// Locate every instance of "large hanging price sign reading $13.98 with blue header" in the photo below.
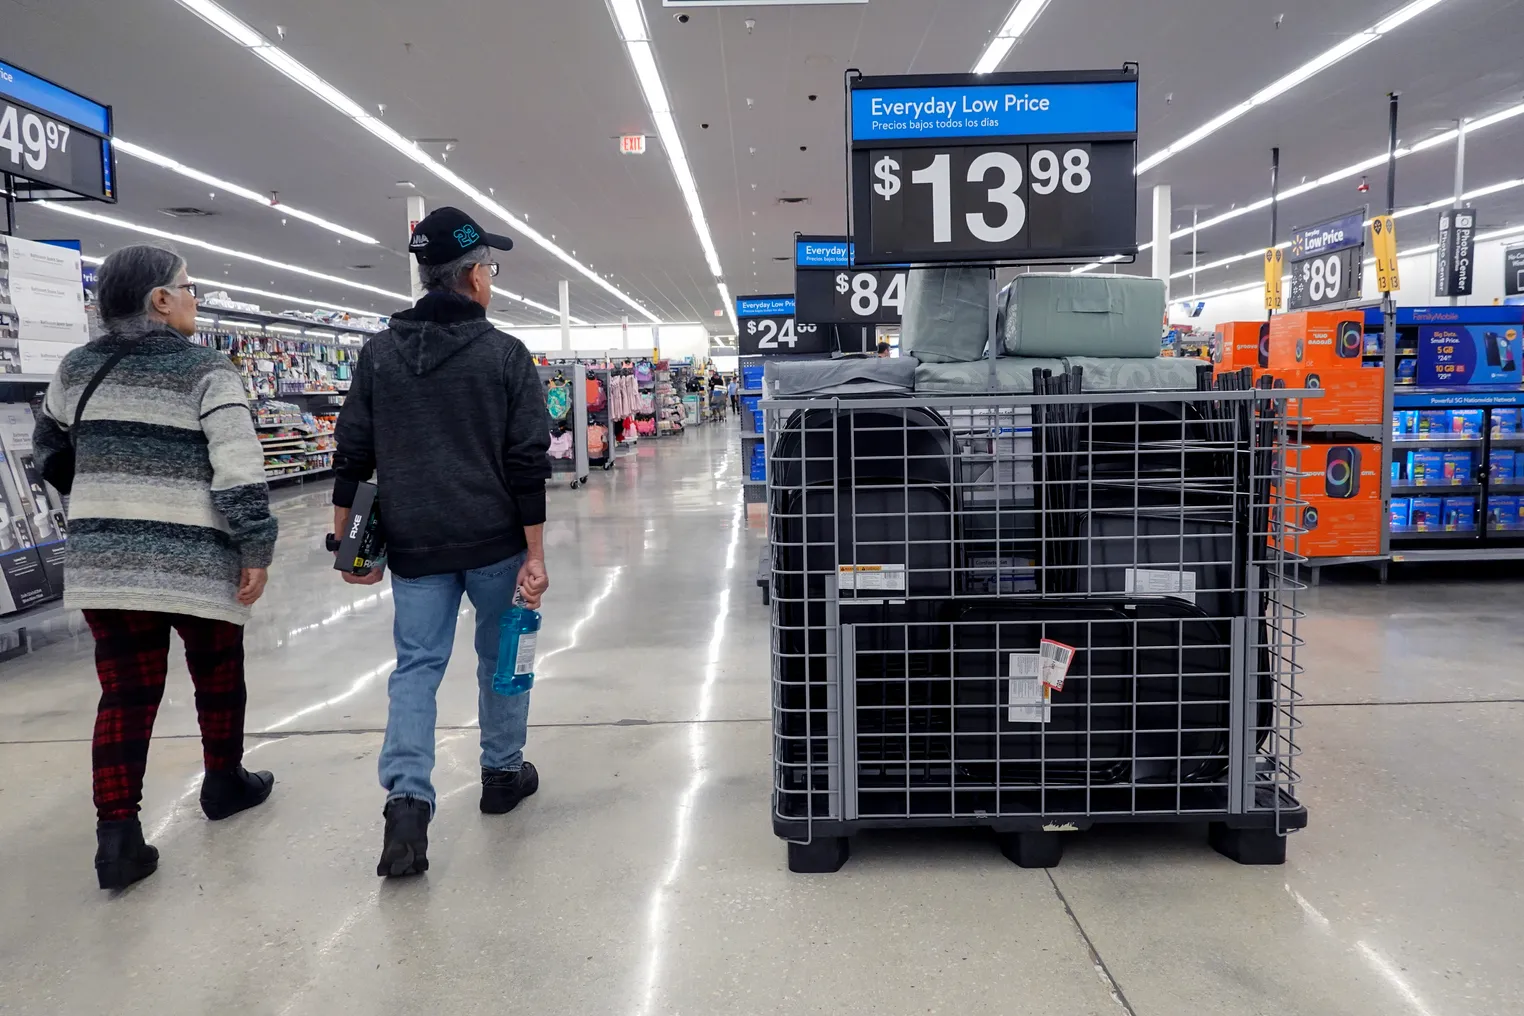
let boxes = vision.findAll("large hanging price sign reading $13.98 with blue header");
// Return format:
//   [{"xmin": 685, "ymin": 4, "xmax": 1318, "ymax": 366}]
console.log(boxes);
[{"xmin": 850, "ymin": 72, "xmax": 1138, "ymax": 265}]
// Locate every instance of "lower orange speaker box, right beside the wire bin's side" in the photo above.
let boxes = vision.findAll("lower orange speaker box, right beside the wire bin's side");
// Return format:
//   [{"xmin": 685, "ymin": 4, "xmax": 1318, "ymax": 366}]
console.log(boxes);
[{"xmin": 1282, "ymin": 442, "xmax": 1384, "ymax": 558}]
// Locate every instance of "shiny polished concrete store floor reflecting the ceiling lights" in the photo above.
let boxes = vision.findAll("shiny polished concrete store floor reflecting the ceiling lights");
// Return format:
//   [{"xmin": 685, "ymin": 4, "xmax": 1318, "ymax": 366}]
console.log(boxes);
[{"xmin": 0, "ymin": 423, "xmax": 1524, "ymax": 1016}]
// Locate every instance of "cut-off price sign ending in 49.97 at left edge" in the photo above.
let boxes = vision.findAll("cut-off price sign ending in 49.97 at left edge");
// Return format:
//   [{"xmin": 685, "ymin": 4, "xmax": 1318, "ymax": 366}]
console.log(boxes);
[{"xmin": 0, "ymin": 62, "xmax": 116, "ymax": 201}]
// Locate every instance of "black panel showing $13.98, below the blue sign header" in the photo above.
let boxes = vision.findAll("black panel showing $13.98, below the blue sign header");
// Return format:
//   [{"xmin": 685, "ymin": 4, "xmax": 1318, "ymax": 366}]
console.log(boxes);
[{"xmin": 853, "ymin": 142, "xmax": 1137, "ymax": 264}]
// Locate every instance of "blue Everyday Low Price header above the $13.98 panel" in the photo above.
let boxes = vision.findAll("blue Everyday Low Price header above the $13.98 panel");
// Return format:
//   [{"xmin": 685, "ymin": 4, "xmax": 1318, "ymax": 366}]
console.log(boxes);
[{"xmin": 852, "ymin": 81, "xmax": 1138, "ymax": 142}]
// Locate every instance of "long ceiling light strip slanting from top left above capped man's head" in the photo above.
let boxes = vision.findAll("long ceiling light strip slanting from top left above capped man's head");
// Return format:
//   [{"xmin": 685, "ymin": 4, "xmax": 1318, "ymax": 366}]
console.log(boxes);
[{"xmin": 177, "ymin": 0, "xmax": 660, "ymax": 323}]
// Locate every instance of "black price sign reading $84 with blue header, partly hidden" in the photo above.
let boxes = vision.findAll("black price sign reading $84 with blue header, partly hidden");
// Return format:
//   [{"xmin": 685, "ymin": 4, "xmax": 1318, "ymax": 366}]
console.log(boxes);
[{"xmin": 794, "ymin": 236, "xmax": 908, "ymax": 324}]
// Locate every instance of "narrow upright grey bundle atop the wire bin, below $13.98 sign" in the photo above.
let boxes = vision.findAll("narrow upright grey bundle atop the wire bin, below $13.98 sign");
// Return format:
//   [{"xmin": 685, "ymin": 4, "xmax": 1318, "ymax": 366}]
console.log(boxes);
[{"xmin": 899, "ymin": 268, "xmax": 989, "ymax": 364}]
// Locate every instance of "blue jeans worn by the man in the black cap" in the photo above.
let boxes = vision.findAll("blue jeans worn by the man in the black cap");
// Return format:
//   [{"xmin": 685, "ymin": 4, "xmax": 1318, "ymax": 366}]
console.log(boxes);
[{"xmin": 379, "ymin": 553, "xmax": 529, "ymax": 807}]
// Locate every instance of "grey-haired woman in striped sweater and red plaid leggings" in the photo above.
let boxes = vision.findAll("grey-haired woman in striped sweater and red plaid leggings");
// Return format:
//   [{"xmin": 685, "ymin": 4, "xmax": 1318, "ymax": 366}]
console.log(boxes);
[{"xmin": 34, "ymin": 245, "xmax": 276, "ymax": 890}]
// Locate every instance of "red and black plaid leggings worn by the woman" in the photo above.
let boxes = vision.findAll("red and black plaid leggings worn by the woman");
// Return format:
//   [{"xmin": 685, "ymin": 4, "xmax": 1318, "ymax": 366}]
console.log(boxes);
[{"xmin": 85, "ymin": 611, "xmax": 247, "ymax": 823}]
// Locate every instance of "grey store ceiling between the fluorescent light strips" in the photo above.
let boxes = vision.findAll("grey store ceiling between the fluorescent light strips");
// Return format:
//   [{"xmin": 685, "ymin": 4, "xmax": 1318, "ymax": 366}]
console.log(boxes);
[{"xmin": 0, "ymin": 0, "xmax": 1524, "ymax": 332}]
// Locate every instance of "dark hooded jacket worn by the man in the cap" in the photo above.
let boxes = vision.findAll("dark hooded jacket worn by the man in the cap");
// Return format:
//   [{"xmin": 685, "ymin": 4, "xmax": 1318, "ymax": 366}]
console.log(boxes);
[{"xmin": 334, "ymin": 292, "xmax": 550, "ymax": 579}]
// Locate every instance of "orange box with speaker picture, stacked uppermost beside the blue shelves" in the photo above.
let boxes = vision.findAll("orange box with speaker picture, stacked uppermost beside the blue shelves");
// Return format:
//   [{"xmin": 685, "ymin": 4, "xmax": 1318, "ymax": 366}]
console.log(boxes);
[{"xmin": 1268, "ymin": 311, "xmax": 1382, "ymax": 427}]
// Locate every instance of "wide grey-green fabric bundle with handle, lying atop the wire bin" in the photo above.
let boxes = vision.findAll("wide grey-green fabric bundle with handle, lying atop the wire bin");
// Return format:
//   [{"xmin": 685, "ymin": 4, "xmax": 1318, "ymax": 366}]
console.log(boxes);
[{"xmin": 1000, "ymin": 273, "xmax": 1164, "ymax": 356}]
